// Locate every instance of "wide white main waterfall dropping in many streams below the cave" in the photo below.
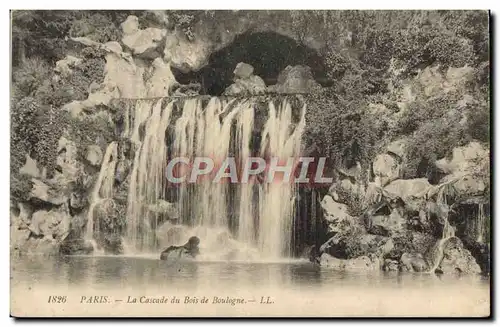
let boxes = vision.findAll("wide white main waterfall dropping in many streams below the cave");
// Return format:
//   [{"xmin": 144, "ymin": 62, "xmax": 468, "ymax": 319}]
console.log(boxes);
[{"xmin": 126, "ymin": 97, "xmax": 305, "ymax": 259}]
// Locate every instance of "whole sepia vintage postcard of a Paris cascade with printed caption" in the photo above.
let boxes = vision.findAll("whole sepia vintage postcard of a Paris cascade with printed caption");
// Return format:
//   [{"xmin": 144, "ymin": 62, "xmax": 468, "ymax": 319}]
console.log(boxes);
[{"xmin": 10, "ymin": 10, "xmax": 492, "ymax": 317}]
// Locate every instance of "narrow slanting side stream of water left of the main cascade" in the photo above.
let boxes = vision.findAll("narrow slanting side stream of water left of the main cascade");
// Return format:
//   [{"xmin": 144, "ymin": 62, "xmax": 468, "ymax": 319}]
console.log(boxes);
[{"xmin": 85, "ymin": 142, "xmax": 118, "ymax": 248}]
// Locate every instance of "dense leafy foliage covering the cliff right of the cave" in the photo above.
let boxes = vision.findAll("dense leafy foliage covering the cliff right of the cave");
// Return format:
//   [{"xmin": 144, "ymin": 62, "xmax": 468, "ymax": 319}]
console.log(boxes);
[{"xmin": 300, "ymin": 11, "xmax": 489, "ymax": 183}]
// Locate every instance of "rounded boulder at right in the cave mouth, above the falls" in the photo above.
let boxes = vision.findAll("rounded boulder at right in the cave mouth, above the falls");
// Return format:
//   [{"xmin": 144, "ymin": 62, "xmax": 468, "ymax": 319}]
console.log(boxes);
[{"xmin": 268, "ymin": 65, "xmax": 321, "ymax": 93}]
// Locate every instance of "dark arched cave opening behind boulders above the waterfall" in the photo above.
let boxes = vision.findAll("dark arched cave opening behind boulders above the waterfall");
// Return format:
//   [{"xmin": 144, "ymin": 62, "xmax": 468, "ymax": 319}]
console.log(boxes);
[{"xmin": 172, "ymin": 32, "xmax": 331, "ymax": 95}]
